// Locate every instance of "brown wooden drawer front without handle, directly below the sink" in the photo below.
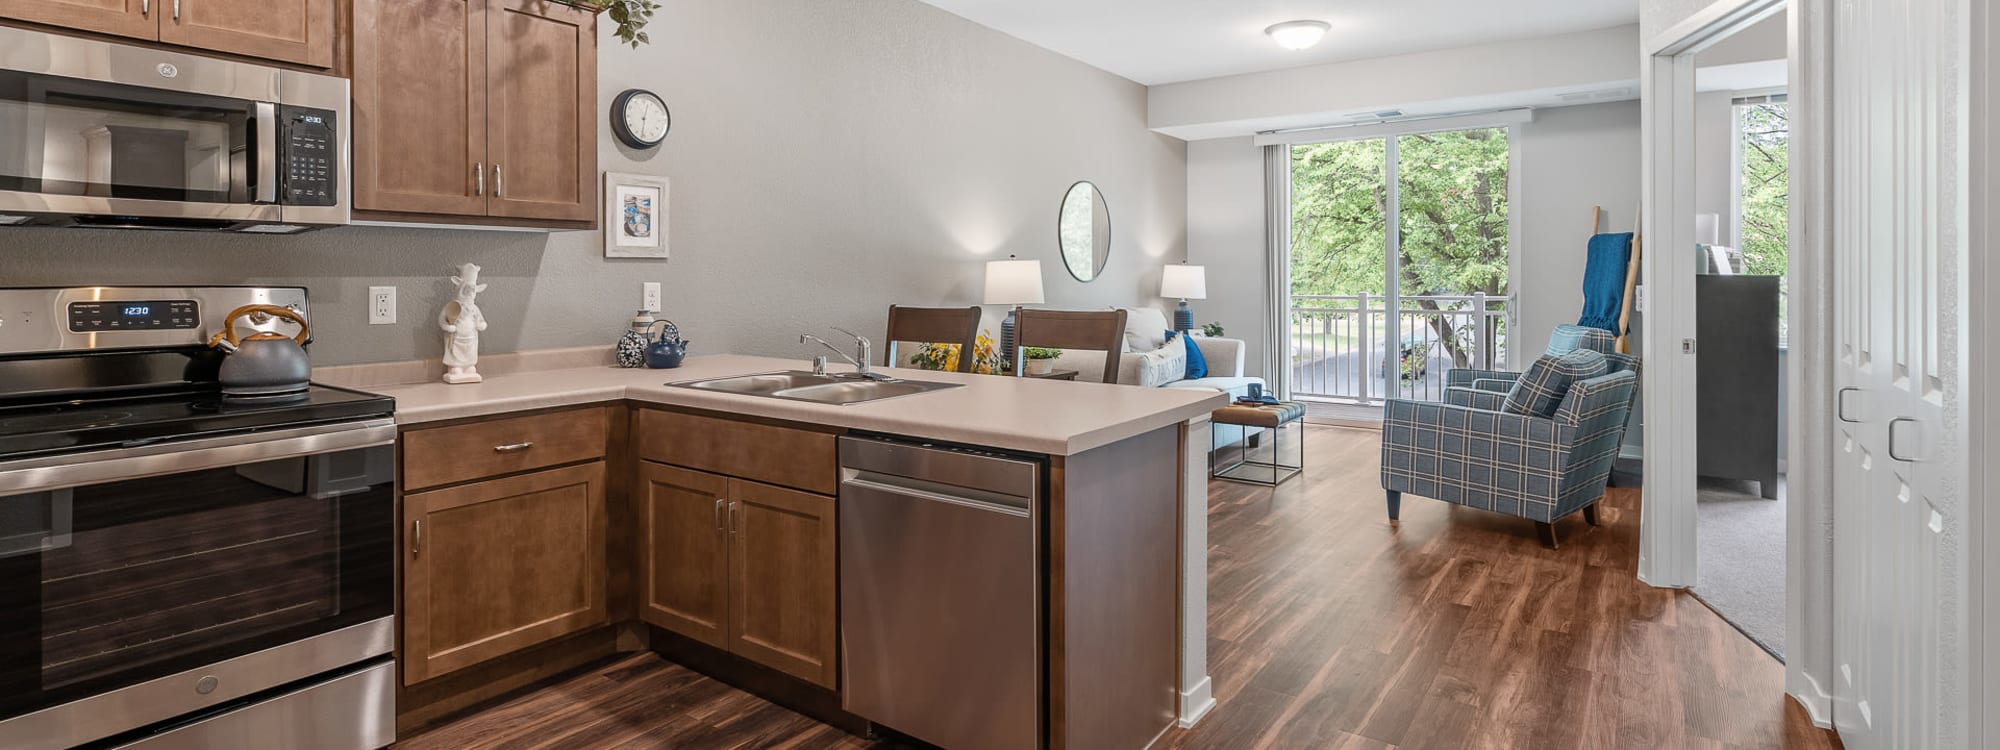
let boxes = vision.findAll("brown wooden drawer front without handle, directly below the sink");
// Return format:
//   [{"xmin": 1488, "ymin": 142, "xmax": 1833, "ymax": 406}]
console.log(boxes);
[{"xmin": 636, "ymin": 410, "xmax": 840, "ymax": 494}]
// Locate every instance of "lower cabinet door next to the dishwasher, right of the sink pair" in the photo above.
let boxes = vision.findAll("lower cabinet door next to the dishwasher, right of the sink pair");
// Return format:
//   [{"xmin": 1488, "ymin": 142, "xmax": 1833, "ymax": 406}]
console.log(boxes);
[{"xmin": 728, "ymin": 480, "xmax": 840, "ymax": 688}]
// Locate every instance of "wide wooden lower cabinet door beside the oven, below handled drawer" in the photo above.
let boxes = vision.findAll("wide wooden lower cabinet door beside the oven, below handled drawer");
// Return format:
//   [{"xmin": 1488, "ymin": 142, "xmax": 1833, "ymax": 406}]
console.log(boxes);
[{"xmin": 402, "ymin": 462, "xmax": 608, "ymax": 684}]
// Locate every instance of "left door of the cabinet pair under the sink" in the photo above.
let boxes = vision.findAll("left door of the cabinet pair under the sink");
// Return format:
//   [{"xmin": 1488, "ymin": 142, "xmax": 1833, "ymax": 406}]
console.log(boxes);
[{"xmin": 636, "ymin": 462, "xmax": 730, "ymax": 648}]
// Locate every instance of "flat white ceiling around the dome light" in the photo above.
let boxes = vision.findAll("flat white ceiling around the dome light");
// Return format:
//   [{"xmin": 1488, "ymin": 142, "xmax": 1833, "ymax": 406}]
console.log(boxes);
[{"xmin": 922, "ymin": 0, "xmax": 1638, "ymax": 86}]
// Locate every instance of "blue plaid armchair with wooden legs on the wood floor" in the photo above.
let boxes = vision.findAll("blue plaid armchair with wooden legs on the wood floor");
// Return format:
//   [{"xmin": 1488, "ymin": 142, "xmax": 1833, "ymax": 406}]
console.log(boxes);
[{"xmin": 1382, "ymin": 354, "xmax": 1640, "ymax": 546}]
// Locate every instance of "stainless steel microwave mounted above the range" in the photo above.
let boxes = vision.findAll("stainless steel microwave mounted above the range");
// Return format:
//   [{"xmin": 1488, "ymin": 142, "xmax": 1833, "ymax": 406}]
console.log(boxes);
[{"xmin": 0, "ymin": 28, "xmax": 352, "ymax": 234}]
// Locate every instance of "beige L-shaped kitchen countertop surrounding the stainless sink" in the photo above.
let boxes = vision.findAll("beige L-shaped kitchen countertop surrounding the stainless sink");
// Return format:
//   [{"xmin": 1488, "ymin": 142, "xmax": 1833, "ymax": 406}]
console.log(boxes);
[{"xmin": 360, "ymin": 354, "xmax": 1228, "ymax": 456}]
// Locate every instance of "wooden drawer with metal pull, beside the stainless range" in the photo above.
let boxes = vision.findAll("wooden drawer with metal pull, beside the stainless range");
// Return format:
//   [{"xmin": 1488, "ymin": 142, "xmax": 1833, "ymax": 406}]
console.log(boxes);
[{"xmin": 402, "ymin": 406, "xmax": 610, "ymax": 492}]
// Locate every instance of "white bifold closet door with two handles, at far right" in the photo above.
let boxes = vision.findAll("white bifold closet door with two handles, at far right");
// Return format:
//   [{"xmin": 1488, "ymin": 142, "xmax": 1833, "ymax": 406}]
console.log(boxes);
[{"xmin": 1830, "ymin": 0, "xmax": 1968, "ymax": 750}]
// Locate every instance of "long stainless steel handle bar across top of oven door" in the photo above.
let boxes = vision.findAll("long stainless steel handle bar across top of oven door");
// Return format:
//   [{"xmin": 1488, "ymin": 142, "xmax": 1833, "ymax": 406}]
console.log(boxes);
[{"xmin": 0, "ymin": 418, "xmax": 396, "ymax": 496}]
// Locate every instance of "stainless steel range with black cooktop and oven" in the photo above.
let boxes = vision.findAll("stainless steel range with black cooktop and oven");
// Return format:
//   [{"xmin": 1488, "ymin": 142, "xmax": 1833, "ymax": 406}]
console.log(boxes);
[{"xmin": 0, "ymin": 288, "xmax": 396, "ymax": 750}]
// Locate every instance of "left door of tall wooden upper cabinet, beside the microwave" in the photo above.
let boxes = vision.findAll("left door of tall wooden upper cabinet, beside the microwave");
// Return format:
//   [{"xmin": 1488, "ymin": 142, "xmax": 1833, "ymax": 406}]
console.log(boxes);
[{"xmin": 354, "ymin": 0, "xmax": 488, "ymax": 216}]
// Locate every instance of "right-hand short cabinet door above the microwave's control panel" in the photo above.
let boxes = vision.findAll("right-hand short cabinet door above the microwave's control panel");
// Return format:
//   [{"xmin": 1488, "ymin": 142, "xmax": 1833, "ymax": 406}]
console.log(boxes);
[{"xmin": 152, "ymin": 0, "xmax": 334, "ymax": 68}]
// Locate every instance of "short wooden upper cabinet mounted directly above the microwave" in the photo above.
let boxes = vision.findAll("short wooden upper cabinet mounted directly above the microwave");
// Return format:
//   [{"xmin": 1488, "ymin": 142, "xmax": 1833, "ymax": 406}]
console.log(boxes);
[{"xmin": 0, "ymin": 0, "xmax": 334, "ymax": 68}]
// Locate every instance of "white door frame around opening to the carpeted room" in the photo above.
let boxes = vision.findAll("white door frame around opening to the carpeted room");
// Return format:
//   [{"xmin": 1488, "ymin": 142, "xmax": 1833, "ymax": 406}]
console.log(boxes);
[{"xmin": 1638, "ymin": 0, "xmax": 1834, "ymax": 726}]
